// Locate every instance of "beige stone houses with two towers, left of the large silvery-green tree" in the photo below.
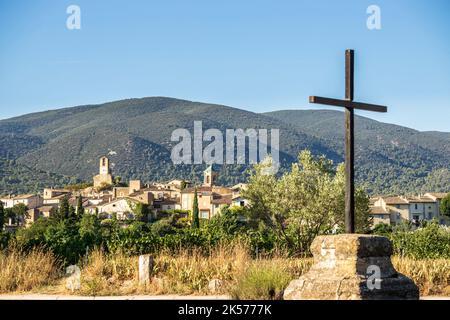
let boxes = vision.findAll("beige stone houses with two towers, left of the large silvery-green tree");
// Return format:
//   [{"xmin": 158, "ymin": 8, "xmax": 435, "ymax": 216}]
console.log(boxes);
[{"xmin": 0, "ymin": 157, "xmax": 247, "ymax": 229}]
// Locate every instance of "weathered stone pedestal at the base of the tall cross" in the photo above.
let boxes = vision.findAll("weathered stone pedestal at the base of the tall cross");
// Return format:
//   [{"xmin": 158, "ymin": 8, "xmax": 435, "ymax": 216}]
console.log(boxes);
[{"xmin": 284, "ymin": 234, "xmax": 419, "ymax": 300}]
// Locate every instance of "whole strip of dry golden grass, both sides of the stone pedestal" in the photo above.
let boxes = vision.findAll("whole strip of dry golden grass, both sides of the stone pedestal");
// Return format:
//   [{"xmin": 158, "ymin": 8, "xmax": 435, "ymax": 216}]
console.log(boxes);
[{"xmin": 0, "ymin": 245, "xmax": 450, "ymax": 299}]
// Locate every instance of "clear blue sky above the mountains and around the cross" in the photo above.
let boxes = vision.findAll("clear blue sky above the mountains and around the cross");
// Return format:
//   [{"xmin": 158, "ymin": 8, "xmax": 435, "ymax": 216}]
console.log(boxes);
[{"xmin": 0, "ymin": 0, "xmax": 450, "ymax": 131}]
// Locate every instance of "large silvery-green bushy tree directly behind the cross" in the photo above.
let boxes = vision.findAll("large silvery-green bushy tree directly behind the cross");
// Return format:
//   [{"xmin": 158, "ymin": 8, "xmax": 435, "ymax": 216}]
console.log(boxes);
[{"xmin": 243, "ymin": 150, "xmax": 370, "ymax": 253}]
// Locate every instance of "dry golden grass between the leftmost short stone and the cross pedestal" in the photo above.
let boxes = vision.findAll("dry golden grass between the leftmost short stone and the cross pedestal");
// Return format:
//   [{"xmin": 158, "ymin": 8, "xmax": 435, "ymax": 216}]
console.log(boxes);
[{"xmin": 75, "ymin": 244, "xmax": 312, "ymax": 299}]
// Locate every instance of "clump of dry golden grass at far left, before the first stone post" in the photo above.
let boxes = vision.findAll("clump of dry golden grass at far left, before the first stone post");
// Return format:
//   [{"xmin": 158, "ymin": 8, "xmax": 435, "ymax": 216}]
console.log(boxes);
[{"xmin": 0, "ymin": 248, "xmax": 61, "ymax": 293}]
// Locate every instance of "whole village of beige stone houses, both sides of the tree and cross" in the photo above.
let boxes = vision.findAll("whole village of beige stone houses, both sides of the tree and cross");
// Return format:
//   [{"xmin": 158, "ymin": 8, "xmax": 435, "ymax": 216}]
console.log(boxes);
[{"xmin": 0, "ymin": 156, "xmax": 450, "ymax": 230}]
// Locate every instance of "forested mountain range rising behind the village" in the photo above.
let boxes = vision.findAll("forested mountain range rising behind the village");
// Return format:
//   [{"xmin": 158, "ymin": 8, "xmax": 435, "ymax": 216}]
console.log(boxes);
[{"xmin": 0, "ymin": 97, "xmax": 450, "ymax": 194}]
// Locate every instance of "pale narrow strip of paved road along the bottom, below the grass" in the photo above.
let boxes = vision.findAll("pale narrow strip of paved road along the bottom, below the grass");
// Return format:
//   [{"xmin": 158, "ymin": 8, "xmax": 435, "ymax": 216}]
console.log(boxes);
[{"xmin": 0, "ymin": 294, "xmax": 450, "ymax": 300}]
